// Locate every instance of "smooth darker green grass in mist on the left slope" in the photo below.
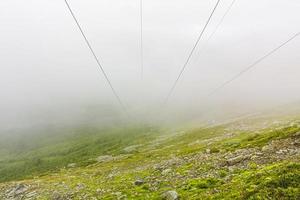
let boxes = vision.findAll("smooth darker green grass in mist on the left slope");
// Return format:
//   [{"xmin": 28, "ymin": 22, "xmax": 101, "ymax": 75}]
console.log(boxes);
[{"xmin": 0, "ymin": 127, "xmax": 157, "ymax": 182}]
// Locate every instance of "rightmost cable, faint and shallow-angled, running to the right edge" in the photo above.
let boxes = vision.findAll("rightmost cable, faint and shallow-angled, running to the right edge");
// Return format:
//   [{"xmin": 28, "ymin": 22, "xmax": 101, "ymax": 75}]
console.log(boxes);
[{"xmin": 208, "ymin": 32, "xmax": 300, "ymax": 97}]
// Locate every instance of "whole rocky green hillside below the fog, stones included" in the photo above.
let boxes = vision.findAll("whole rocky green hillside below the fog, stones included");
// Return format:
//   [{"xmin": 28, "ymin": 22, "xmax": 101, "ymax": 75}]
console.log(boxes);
[{"xmin": 0, "ymin": 117, "xmax": 300, "ymax": 200}]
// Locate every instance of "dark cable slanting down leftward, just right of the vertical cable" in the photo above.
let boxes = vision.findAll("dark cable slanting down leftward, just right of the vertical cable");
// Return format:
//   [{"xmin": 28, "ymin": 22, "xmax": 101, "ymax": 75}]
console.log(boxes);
[{"xmin": 164, "ymin": 0, "xmax": 221, "ymax": 104}]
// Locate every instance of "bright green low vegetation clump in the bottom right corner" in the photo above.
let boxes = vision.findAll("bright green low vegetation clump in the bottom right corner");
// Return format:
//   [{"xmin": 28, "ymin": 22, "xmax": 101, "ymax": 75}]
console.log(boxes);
[{"xmin": 214, "ymin": 162, "xmax": 300, "ymax": 200}]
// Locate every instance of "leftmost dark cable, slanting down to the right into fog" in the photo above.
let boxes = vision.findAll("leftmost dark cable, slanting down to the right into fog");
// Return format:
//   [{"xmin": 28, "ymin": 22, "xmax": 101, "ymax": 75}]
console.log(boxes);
[{"xmin": 64, "ymin": 0, "xmax": 127, "ymax": 113}]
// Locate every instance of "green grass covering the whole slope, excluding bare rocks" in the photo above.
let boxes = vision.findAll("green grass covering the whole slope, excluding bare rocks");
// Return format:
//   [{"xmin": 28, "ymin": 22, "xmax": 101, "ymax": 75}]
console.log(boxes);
[{"xmin": 0, "ymin": 116, "xmax": 300, "ymax": 200}]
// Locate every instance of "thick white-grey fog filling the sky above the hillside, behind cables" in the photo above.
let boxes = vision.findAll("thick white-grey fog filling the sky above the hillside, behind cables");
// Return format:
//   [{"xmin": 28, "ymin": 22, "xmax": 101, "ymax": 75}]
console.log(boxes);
[{"xmin": 0, "ymin": 0, "xmax": 300, "ymax": 134}]
